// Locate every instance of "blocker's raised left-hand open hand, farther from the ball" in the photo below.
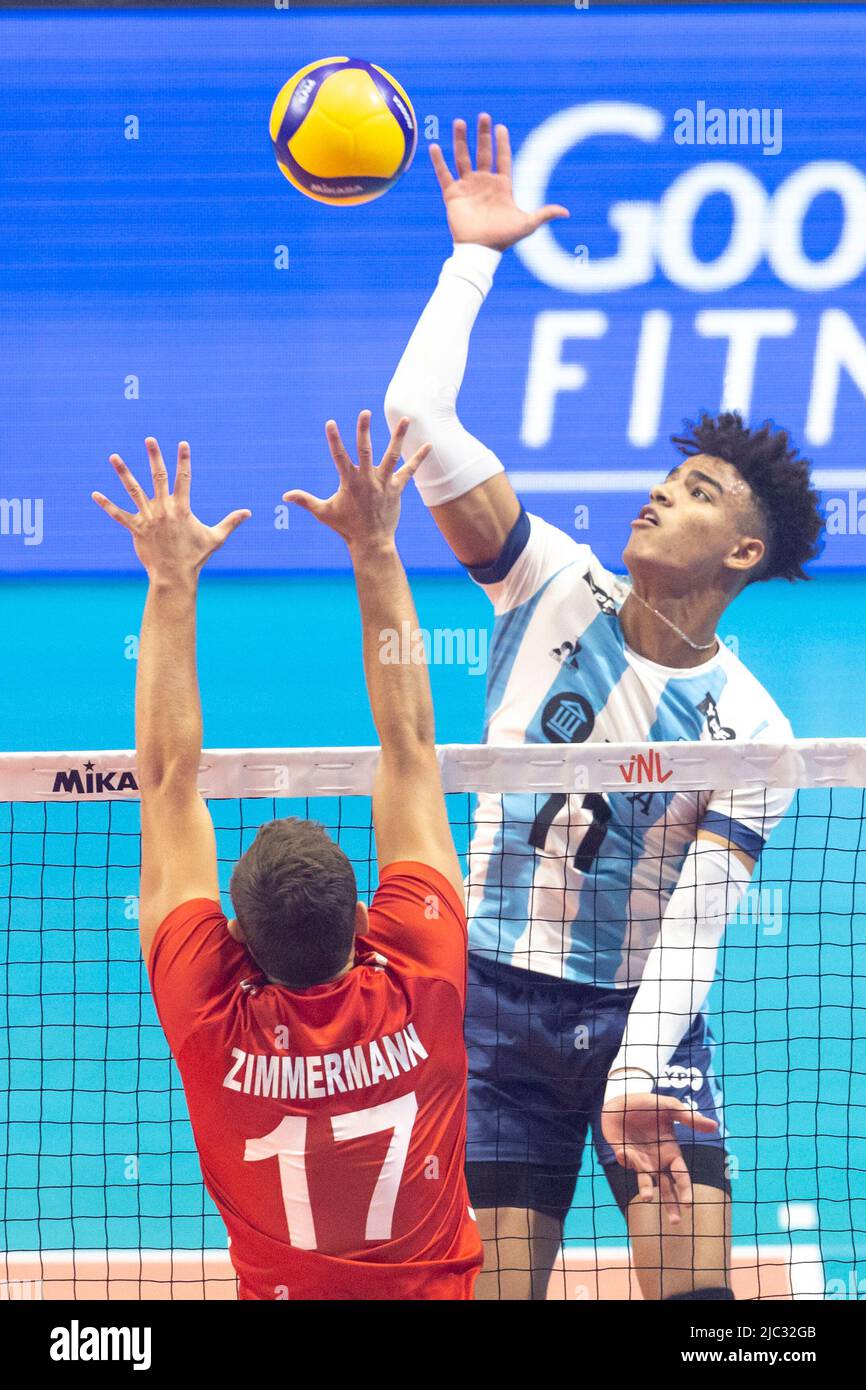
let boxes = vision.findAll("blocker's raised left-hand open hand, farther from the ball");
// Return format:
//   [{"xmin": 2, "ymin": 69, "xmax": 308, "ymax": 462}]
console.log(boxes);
[{"xmin": 90, "ymin": 438, "xmax": 252, "ymax": 580}]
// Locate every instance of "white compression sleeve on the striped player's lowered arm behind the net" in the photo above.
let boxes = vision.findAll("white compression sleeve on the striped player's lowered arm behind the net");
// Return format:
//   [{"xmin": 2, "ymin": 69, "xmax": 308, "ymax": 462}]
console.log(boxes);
[{"xmin": 606, "ymin": 840, "xmax": 751, "ymax": 1099}]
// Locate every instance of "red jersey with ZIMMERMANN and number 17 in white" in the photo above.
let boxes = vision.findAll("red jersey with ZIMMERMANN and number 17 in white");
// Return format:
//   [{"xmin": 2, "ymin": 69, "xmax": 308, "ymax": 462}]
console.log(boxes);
[{"xmin": 149, "ymin": 863, "xmax": 481, "ymax": 1300}]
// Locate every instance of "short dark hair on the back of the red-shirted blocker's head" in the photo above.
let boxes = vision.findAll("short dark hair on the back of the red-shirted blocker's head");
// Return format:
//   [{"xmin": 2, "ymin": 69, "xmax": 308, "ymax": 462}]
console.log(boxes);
[{"xmin": 229, "ymin": 816, "xmax": 357, "ymax": 990}]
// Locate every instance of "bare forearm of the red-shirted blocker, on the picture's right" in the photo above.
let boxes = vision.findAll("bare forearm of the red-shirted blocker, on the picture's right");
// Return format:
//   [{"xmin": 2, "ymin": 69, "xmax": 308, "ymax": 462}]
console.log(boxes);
[{"xmin": 350, "ymin": 541, "xmax": 434, "ymax": 751}]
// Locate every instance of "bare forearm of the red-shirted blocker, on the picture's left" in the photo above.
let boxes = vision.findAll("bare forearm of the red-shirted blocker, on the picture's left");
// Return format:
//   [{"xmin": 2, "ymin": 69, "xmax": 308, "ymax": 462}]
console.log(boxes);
[{"xmin": 135, "ymin": 574, "xmax": 202, "ymax": 791}]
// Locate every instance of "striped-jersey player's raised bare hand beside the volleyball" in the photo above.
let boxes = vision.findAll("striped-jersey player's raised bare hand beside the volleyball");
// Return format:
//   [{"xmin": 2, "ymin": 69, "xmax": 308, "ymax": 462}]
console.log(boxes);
[{"xmin": 430, "ymin": 111, "xmax": 570, "ymax": 252}]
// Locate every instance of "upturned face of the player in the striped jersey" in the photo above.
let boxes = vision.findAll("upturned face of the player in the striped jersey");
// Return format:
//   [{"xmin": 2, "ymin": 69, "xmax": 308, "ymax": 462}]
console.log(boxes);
[{"xmin": 623, "ymin": 453, "xmax": 760, "ymax": 581}]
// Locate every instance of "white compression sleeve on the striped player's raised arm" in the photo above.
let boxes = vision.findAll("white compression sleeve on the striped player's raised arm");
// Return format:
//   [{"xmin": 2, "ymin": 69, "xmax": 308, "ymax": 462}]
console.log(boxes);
[{"xmin": 385, "ymin": 242, "xmax": 503, "ymax": 507}]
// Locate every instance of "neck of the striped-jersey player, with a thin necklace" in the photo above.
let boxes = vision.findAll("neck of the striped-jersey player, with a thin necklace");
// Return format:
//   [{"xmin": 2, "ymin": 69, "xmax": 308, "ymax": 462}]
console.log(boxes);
[{"xmin": 620, "ymin": 578, "xmax": 724, "ymax": 669}]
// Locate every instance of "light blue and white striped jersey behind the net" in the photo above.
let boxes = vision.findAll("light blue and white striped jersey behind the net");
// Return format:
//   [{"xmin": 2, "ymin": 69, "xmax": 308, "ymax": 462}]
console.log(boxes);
[{"xmin": 467, "ymin": 512, "xmax": 792, "ymax": 988}]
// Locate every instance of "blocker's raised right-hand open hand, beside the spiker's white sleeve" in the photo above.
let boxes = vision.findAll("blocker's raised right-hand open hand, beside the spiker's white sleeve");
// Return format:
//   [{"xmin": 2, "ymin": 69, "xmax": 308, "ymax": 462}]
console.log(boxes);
[{"xmin": 282, "ymin": 410, "xmax": 432, "ymax": 548}]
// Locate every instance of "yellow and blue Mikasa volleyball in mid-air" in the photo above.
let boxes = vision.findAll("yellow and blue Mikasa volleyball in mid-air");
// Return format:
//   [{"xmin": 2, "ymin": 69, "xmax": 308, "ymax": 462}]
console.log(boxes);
[{"xmin": 270, "ymin": 58, "xmax": 418, "ymax": 207}]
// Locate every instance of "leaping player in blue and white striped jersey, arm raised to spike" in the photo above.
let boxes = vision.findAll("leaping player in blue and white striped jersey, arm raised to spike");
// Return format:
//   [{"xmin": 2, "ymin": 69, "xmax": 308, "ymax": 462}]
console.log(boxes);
[{"xmin": 385, "ymin": 115, "xmax": 822, "ymax": 1298}]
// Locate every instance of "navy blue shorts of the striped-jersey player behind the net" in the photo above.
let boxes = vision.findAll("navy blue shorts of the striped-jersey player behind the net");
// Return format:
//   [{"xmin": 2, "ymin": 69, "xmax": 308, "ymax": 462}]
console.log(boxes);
[{"xmin": 466, "ymin": 952, "xmax": 724, "ymax": 1191}]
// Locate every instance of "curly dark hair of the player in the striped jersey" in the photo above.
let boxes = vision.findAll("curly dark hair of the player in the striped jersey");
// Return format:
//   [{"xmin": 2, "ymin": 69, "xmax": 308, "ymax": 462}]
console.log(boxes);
[{"xmin": 671, "ymin": 410, "xmax": 824, "ymax": 582}]
